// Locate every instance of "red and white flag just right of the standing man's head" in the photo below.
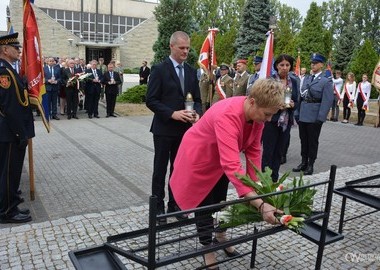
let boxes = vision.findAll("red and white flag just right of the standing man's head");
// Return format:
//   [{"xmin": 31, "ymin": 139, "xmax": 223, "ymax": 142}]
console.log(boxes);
[{"xmin": 198, "ymin": 28, "xmax": 219, "ymax": 71}]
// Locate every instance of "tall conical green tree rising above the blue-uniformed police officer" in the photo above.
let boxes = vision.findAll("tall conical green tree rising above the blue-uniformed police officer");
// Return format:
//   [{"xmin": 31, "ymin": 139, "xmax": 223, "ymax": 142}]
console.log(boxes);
[{"xmin": 294, "ymin": 2, "xmax": 330, "ymax": 63}]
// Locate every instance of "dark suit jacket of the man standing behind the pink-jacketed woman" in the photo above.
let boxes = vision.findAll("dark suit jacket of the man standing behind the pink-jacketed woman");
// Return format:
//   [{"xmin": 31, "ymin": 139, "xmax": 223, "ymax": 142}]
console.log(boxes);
[{"xmin": 146, "ymin": 58, "xmax": 202, "ymax": 136}]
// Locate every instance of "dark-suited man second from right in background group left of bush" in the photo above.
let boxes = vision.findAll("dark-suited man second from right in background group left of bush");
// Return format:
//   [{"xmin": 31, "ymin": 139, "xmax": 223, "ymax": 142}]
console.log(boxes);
[{"xmin": 86, "ymin": 60, "xmax": 103, "ymax": 119}]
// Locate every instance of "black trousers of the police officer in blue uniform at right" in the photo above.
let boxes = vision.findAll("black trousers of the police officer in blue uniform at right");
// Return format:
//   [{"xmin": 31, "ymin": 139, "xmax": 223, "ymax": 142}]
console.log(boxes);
[{"xmin": 298, "ymin": 121, "xmax": 322, "ymax": 162}]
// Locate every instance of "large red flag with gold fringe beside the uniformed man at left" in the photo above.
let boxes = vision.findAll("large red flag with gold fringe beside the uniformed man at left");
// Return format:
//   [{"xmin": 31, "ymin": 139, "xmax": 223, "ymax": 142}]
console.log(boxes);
[{"xmin": 21, "ymin": 0, "xmax": 50, "ymax": 132}]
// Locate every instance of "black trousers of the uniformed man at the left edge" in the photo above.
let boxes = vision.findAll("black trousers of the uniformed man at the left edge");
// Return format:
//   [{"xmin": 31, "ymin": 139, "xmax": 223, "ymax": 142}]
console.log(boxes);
[{"xmin": 0, "ymin": 142, "xmax": 26, "ymax": 217}]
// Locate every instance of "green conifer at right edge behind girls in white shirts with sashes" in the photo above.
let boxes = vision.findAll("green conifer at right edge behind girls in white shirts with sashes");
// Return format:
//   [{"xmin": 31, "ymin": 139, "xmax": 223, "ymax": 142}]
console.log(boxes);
[{"xmin": 347, "ymin": 39, "xmax": 379, "ymax": 98}]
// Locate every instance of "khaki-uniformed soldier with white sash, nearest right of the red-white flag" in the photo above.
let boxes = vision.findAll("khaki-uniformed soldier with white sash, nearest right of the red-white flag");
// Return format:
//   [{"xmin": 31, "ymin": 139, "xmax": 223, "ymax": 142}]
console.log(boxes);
[{"xmin": 212, "ymin": 64, "xmax": 234, "ymax": 104}]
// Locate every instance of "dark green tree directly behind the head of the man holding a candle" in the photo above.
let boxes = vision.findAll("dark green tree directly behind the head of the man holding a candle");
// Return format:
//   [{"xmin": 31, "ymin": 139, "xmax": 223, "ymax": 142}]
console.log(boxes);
[{"xmin": 153, "ymin": 0, "xmax": 197, "ymax": 65}]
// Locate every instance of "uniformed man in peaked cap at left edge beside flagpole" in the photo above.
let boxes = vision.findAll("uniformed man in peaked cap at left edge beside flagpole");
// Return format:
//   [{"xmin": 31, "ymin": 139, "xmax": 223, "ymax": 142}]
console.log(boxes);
[{"xmin": 0, "ymin": 33, "xmax": 34, "ymax": 223}]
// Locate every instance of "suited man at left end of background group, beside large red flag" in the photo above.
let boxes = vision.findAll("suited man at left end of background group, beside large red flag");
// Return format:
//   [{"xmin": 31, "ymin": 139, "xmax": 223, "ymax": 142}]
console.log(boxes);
[{"xmin": 44, "ymin": 57, "xmax": 61, "ymax": 120}]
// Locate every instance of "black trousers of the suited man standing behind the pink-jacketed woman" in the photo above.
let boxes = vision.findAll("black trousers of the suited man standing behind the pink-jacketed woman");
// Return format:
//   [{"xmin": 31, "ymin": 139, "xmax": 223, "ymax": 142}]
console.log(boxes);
[{"xmin": 152, "ymin": 135, "xmax": 182, "ymax": 212}]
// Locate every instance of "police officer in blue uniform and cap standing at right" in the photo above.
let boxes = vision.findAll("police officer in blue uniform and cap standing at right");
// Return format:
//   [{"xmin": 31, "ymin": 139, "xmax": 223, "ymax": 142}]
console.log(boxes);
[{"xmin": 293, "ymin": 53, "xmax": 334, "ymax": 175}]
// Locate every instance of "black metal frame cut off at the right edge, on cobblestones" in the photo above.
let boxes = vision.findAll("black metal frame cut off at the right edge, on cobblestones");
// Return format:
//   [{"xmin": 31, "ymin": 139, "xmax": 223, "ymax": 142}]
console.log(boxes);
[{"xmin": 334, "ymin": 174, "xmax": 380, "ymax": 234}]
